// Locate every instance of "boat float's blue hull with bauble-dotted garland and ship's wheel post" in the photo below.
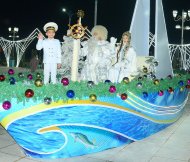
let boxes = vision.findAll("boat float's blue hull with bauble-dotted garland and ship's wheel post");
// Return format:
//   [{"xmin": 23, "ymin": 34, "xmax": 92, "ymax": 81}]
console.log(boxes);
[{"xmin": 0, "ymin": 0, "xmax": 190, "ymax": 159}]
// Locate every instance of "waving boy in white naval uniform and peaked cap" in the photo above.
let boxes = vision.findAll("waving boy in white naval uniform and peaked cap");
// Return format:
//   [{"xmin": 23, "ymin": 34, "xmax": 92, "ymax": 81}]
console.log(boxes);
[{"xmin": 36, "ymin": 22, "xmax": 61, "ymax": 84}]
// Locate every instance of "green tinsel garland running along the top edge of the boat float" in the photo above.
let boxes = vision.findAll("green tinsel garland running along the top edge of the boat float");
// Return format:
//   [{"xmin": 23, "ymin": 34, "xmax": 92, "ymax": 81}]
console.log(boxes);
[{"xmin": 0, "ymin": 72, "xmax": 190, "ymax": 102}]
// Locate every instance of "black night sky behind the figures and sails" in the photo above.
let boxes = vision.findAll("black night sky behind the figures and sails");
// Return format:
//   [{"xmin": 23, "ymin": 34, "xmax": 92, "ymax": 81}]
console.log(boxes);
[{"xmin": 0, "ymin": 0, "xmax": 190, "ymax": 44}]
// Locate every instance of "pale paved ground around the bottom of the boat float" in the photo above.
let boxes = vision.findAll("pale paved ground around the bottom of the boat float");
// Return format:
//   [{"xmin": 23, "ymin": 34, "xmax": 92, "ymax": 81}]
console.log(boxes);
[{"xmin": 0, "ymin": 95, "xmax": 190, "ymax": 162}]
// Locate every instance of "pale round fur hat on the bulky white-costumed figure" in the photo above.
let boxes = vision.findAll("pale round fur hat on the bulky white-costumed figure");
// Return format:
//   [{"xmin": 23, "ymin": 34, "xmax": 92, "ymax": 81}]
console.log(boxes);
[{"xmin": 91, "ymin": 25, "xmax": 108, "ymax": 40}]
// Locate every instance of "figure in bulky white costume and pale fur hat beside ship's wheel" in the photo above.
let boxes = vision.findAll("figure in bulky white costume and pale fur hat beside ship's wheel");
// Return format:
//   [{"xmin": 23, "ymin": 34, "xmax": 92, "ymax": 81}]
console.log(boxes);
[{"xmin": 81, "ymin": 25, "xmax": 116, "ymax": 84}]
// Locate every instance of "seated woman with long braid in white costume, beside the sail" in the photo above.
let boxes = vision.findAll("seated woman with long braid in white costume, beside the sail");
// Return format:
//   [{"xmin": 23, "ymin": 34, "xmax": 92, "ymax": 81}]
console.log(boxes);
[{"xmin": 108, "ymin": 32, "xmax": 137, "ymax": 83}]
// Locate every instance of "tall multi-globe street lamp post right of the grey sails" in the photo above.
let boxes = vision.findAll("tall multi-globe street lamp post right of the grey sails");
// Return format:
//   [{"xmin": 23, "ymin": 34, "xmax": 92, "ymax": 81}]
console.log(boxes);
[{"xmin": 173, "ymin": 10, "xmax": 190, "ymax": 70}]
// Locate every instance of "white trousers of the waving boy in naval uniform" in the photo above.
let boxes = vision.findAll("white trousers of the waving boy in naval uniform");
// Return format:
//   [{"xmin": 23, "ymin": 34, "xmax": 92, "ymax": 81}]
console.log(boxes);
[{"xmin": 44, "ymin": 63, "xmax": 57, "ymax": 84}]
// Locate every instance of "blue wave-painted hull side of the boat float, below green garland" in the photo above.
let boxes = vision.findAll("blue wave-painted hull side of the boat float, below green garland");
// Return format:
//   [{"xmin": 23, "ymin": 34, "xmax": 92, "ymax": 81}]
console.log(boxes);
[{"xmin": 0, "ymin": 89, "xmax": 189, "ymax": 159}]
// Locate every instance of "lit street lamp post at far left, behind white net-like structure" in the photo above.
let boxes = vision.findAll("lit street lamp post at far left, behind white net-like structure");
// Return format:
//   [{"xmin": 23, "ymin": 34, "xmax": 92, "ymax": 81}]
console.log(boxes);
[{"xmin": 8, "ymin": 27, "xmax": 19, "ymax": 67}]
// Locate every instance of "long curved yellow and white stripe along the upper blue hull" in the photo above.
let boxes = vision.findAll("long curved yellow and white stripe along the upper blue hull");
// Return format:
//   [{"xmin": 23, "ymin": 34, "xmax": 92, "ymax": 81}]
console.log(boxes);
[{"xmin": 1, "ymin": 100, "xmax": 177, "ymax": 128}]
